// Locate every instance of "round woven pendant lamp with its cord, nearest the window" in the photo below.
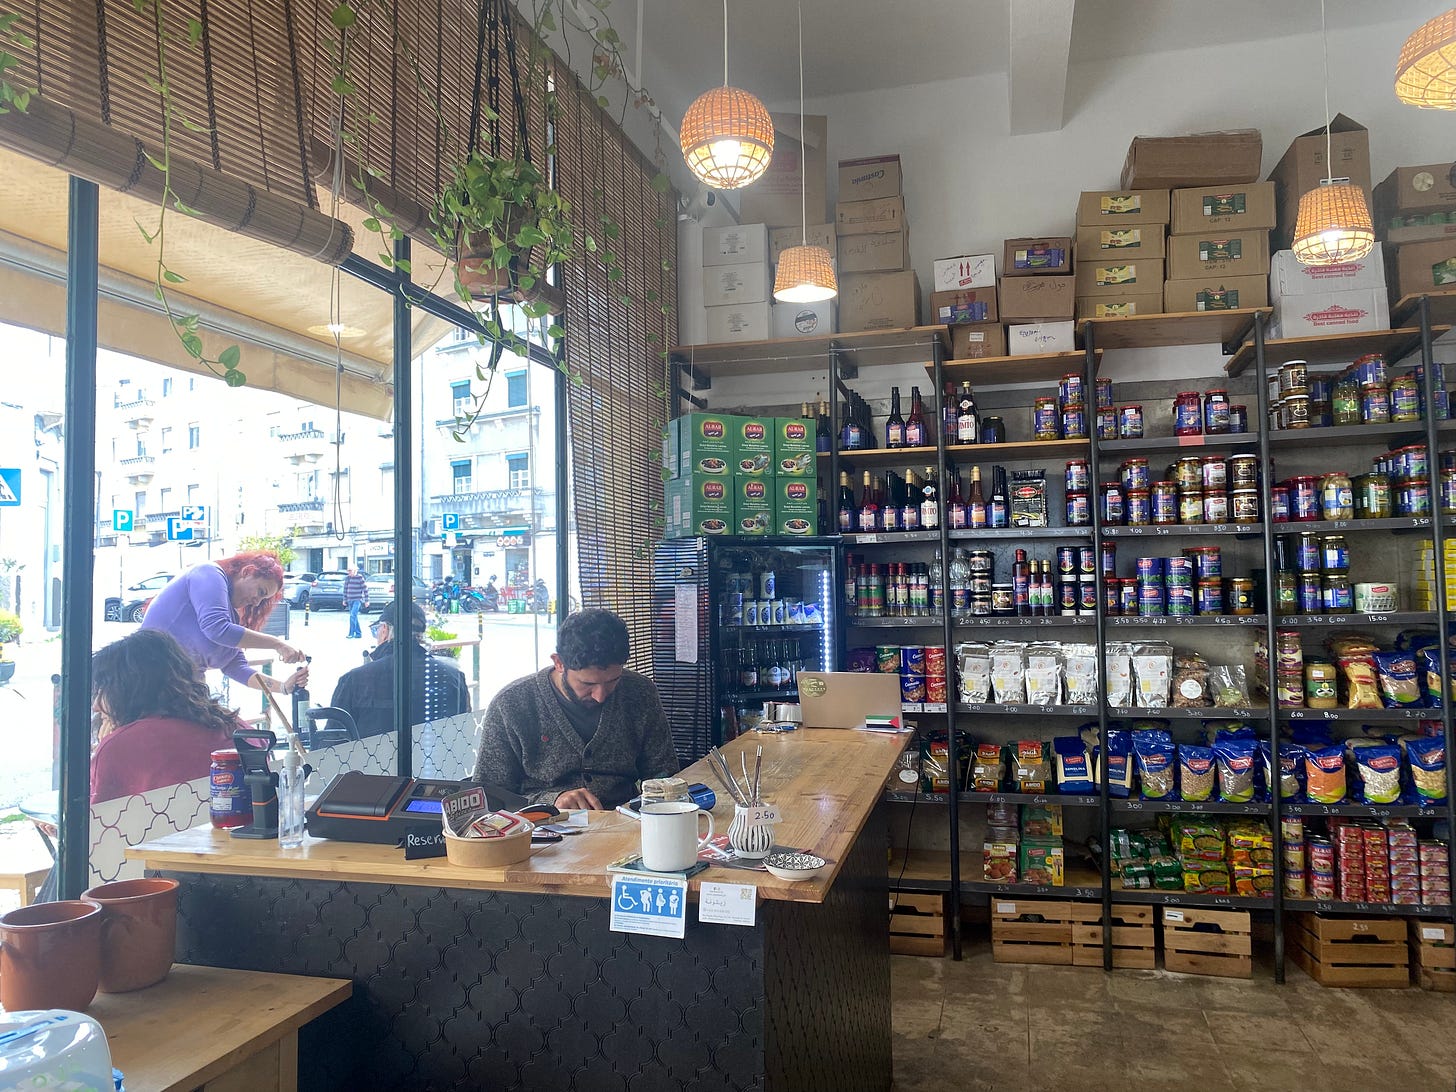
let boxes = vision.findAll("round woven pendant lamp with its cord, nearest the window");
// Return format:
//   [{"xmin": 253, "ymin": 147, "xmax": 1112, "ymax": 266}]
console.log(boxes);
[{"xmin": 678, "ymin": 0, "xmax": 773, "ymax": 189}]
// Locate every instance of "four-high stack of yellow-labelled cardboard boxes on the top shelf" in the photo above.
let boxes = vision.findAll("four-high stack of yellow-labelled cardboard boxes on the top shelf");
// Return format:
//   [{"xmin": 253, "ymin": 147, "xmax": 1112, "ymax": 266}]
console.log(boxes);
[{"xmin": 1076, "ymin": 189, "xmax": 1169, "ymax": 320}]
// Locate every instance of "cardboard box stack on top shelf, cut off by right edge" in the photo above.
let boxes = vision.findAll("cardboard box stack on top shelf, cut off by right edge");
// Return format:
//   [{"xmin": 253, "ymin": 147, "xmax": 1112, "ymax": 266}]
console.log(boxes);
[{"xmin": 1374, "ymin": 163, "xmax": 1456, "ymax": 303}]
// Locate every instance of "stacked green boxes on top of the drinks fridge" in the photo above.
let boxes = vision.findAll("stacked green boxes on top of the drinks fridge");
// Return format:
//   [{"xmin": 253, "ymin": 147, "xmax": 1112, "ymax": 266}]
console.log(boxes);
[{"xmin": 662, "ymin": 414, "xmax": 818, "ymax": 539}]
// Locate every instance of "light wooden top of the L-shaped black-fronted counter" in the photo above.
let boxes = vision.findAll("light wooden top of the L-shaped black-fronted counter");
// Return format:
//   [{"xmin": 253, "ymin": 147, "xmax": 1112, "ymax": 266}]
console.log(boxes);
[{"xmin": 127, "ymin": 728, "xmax": 914, "ymax": 903}]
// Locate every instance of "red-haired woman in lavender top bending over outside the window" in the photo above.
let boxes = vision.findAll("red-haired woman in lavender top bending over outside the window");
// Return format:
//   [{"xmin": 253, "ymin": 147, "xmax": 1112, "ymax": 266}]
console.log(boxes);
[{"xmin": 141, "ymin": 550, "xmax": 309, "ymax": 693}]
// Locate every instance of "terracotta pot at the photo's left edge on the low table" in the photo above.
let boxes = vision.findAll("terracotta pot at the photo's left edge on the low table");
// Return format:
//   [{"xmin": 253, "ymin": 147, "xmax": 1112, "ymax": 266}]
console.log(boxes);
[{"xmin": 0, "ymin": 900, "xmax": 102, "ymax": 1012}]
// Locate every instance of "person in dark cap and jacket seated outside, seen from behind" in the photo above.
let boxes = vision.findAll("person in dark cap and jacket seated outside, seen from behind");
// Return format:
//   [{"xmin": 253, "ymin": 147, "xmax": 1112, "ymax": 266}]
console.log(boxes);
[{"xmin": 331, "ymin": 600, "xmax": 470, "ymax": 737}]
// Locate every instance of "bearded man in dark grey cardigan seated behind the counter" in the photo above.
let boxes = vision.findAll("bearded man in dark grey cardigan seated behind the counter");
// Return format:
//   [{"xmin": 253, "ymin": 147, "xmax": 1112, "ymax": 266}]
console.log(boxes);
[{"xmin": 475, "ymin": 609, "xmax": 678, "ymax": 811}]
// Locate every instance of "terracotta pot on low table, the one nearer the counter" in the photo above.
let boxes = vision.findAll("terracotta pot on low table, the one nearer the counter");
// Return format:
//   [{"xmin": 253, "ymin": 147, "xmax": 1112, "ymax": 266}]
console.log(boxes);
[{"xmin": 82, "ymin": 879, "xmax": 178, "ymax": 993}]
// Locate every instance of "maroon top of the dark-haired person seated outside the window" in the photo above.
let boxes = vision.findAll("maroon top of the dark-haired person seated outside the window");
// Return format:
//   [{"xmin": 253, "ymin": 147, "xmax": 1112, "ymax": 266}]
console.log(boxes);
[{"xmin": 92, "ymin": 716, "xmax": 242, "ymax": 804}]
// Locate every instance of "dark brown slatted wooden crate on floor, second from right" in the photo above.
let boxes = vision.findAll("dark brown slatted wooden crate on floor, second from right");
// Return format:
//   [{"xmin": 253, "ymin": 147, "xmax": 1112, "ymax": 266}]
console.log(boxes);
[{"xmin": 1284, "ymin": 913, "xmax": 1411, "ymax": 990}]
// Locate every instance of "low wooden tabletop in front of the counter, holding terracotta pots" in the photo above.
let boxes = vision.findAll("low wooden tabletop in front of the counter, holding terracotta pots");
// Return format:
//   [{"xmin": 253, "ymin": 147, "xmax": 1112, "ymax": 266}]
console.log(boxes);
[{"xmin": 86, "ymin": 964, "xmax": 354, "ymax": 1092}]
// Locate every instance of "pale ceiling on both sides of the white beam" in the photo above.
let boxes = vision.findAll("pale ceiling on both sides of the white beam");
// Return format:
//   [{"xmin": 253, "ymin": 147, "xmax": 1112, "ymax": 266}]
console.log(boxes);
[{"xmin": 634, "ymin": 0, "xmax": 1432, "ymax": 127}]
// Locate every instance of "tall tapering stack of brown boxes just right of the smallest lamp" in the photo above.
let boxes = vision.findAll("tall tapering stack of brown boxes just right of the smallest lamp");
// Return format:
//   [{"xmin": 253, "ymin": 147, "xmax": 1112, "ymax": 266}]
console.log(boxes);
[{"xmin": 834, "ymin": 156, "xmax": 920, "ymax": 332}]
